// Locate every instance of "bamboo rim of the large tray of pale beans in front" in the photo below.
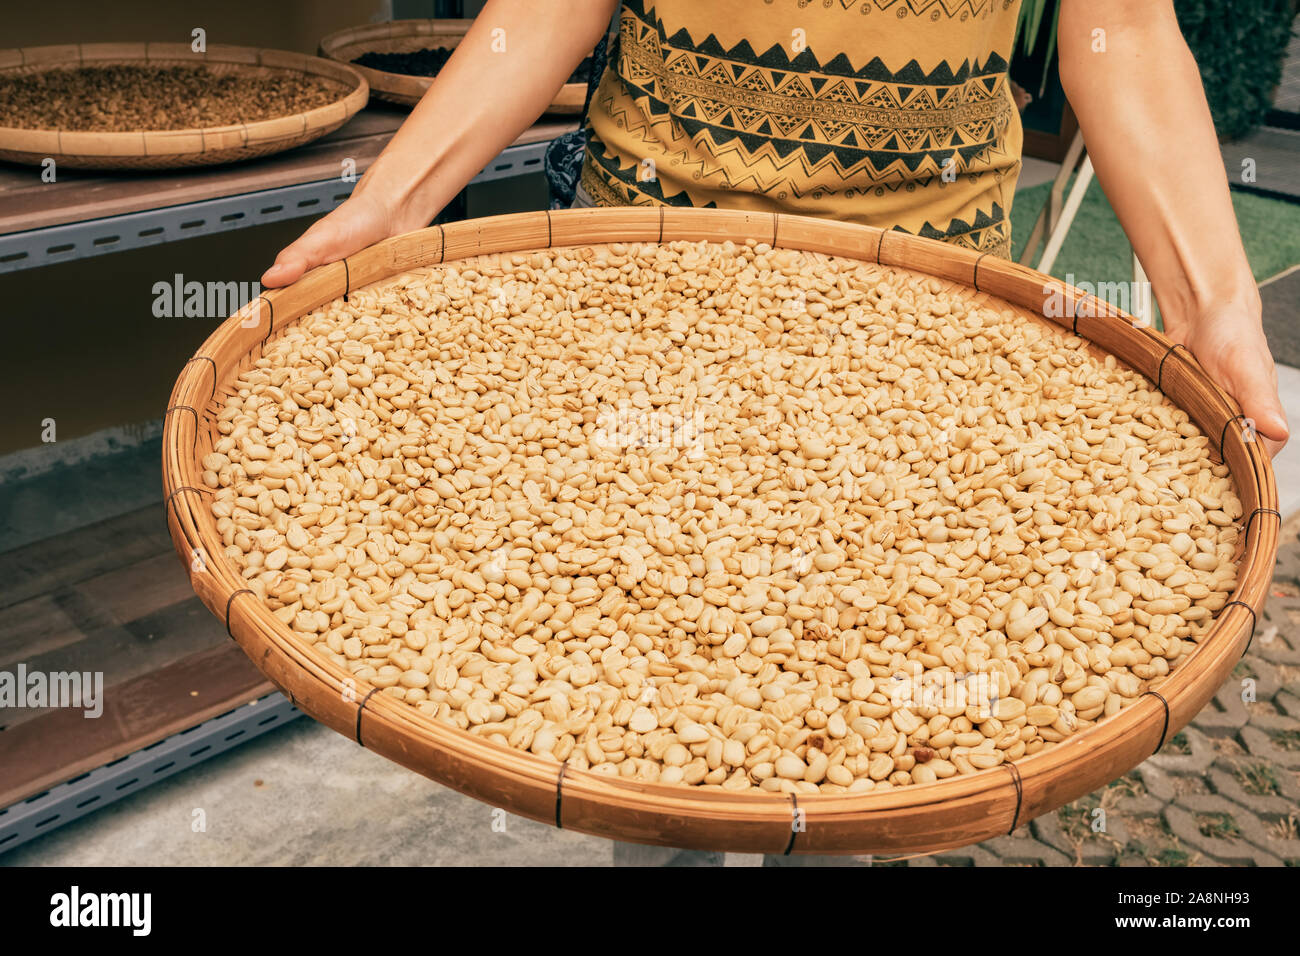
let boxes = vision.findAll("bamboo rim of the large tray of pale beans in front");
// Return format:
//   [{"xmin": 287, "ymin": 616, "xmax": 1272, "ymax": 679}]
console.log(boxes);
[{"xmin": 163, "ymin": 207, "xmax": 1279, "ymax": 853}]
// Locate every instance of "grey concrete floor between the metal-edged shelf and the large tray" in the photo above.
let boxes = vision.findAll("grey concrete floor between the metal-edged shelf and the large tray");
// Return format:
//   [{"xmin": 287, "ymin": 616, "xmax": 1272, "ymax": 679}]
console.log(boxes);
[{"xmin": 0, "ymin": 718, "xmax": 614, "ymax": 866}]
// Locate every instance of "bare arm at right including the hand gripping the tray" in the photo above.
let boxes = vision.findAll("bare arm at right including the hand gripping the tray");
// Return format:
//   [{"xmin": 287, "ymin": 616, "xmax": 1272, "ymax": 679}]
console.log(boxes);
[{"xmin": 1058, "ymin": 0, "xmax": 1290, "ymax": 454}]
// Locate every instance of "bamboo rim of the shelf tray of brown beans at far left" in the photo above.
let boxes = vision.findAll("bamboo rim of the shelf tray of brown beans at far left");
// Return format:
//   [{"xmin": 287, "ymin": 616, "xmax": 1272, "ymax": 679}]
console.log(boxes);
[{"xmin": 0, "ymin": 43, "xmax": 369, "ymax": 169}]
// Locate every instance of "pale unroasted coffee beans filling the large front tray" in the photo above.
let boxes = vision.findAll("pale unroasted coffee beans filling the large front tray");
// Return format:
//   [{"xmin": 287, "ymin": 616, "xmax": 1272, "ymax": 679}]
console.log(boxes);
[{"xmin": 218, "ymin": 242, "xmax": 1243, "ymax": 795}]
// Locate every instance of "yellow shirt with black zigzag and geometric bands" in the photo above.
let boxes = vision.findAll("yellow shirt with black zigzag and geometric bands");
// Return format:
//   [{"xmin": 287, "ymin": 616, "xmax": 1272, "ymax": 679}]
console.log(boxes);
[{"xmin": 581, "ymin": 0, "xmax": 1022, "ymax": 256}]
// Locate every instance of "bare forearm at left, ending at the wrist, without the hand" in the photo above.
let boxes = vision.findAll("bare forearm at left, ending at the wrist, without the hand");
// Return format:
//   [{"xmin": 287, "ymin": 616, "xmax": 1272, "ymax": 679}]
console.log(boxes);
[{"xmin": 356, "ymin": 0, "xmax": 614, "ymax": 232}]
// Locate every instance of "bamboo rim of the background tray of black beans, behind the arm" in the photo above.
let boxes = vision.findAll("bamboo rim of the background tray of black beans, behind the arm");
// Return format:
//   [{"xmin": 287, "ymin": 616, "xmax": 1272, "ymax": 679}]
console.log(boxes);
[{"xmin": 320, "ymin": 20, "xmax": 586, "ymax": 116}]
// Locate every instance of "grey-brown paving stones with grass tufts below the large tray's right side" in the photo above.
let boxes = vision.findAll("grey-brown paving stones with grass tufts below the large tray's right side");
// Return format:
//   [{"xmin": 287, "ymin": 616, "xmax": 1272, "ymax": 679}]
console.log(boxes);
[{"xmin": 874, "ymin": 519, "xmax": 1300, "ymax": 866}]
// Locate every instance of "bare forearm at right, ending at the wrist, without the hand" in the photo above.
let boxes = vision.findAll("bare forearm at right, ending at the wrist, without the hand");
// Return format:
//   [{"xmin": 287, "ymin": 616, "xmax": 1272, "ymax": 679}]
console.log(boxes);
[{"xmin": 1058, "ymin": 0, "xmax": 1258, "ymax": 326}]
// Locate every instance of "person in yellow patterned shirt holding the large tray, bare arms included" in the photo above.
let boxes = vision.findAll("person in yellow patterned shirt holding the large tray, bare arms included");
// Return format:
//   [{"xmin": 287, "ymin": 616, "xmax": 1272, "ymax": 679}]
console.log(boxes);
[{"xmin": 263, "ymin": 0, "xmax": 1288, "ymax": 454}]
